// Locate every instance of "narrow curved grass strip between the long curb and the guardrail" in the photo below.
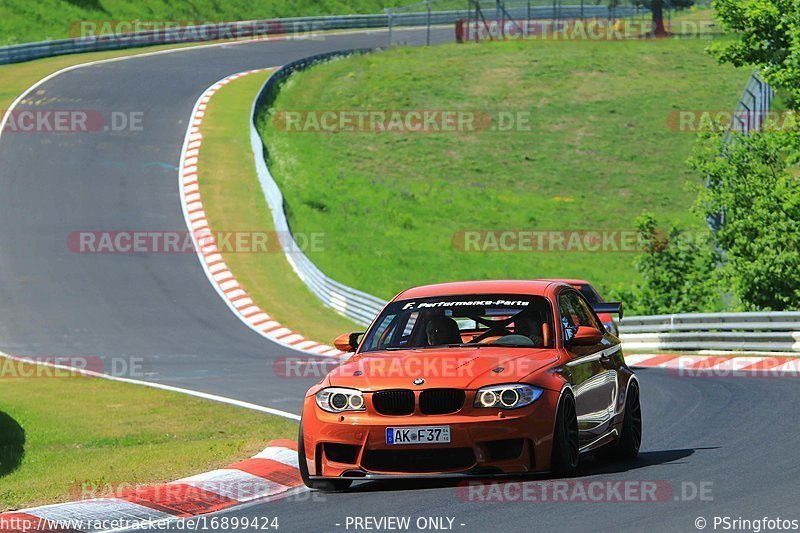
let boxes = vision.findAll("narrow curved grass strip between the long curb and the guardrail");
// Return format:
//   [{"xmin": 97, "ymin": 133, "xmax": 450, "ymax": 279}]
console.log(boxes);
[{"xmin": 198, "ymin": 69, "xmax": 361, "ymax": 344}]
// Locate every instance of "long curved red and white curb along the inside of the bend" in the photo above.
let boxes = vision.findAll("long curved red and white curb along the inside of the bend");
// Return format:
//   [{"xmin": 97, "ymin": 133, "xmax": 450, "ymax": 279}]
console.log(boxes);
[{"xmin": 179, "ymin": 69, "xmax": 344, "ymax": 357}]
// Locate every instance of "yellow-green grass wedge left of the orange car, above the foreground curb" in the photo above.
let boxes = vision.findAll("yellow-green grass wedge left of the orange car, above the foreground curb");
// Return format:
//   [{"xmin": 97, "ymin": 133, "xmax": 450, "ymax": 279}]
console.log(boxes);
[{"xmin": 0, "ymin": 358, "xmax": 297, "ymax": 511}]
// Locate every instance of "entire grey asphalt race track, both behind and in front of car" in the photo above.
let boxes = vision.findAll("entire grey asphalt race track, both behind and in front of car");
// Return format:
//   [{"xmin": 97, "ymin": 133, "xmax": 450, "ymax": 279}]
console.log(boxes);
[{"xmin": 0, "ymin": 23, "xmax": 800, "ymax": 532}]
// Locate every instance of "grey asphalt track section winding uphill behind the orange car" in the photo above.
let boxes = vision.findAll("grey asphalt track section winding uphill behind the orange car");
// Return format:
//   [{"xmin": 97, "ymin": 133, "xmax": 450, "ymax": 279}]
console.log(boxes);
[{"xmin": 0, "ymin": 30, "xmax": 453, "ymax": 413}]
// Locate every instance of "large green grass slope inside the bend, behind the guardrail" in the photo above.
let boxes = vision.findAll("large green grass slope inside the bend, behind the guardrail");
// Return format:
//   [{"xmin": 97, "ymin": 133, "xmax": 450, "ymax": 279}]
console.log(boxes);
[{"xmin": 260, "ymin": 39, "xmax": 749, "ymax": 298}]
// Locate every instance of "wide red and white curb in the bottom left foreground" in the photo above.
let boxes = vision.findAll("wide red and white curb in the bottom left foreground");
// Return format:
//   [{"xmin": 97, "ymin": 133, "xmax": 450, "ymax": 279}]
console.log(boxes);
[{"xmin": 0, "ymin": 440, "xmax": 305, "ymax": 533}]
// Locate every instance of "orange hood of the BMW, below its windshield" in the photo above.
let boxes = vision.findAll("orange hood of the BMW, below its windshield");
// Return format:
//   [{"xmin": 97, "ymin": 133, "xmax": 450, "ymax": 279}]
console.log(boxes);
[{"xmin": 328, "ymin": 346, "xmax": 558, "ymax": 391}]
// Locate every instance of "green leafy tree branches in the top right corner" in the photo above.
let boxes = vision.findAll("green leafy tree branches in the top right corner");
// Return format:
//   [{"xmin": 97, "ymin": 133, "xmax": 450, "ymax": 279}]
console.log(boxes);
[{"xmin": 711, "ymin": 0, "xmax": 800, "ymax": 109}]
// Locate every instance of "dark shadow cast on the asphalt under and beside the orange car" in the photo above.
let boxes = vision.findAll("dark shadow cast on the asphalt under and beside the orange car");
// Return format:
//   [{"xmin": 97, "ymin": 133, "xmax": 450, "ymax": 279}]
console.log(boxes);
[{"xmin": 346, "ymin": 447, "xmax": 717, "ymax": 493}]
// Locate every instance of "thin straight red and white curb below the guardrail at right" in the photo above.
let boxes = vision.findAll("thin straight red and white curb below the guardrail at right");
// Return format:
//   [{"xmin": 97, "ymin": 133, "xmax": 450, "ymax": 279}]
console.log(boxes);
[{"xmin": 625, "ymin": 354, "xmax": 800, "ymax": 377}]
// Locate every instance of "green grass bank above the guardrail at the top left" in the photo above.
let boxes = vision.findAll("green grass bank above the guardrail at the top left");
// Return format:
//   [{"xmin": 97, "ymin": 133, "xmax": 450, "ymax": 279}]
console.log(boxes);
[{"xmin": 0, "ymin": 0, "xmax": 412, "ymax": 46}]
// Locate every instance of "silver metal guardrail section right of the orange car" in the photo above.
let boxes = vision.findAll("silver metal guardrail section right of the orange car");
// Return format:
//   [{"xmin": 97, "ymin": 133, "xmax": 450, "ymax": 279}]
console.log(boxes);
[{"xmin": 620, "ymin": 312, "xmax": 800, "ymax": 352}]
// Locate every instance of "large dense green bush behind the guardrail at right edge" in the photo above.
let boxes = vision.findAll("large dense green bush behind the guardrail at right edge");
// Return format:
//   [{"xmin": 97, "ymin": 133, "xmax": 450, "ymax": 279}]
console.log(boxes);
[{"xmin": 690, "ymin": 125, "xmax": 800, "ymax": 311}]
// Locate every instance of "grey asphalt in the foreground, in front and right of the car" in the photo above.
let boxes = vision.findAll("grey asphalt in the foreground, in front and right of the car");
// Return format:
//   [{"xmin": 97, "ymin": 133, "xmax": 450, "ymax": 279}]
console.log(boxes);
[{"xmin": 227, "ymin": 369, "xmax": 800, "ymax": 533}]
